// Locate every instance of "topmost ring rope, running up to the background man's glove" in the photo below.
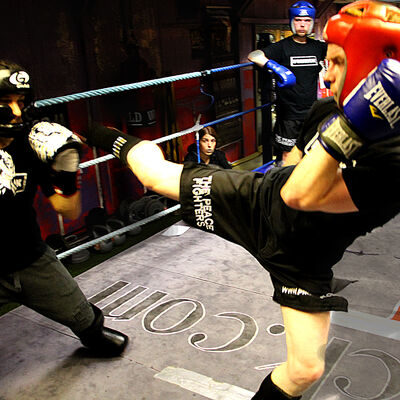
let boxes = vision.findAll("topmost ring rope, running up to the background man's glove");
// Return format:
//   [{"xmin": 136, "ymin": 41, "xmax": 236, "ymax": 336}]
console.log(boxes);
[{"xmin": 33, "ymin": 62, "xmax": 254, "ymax": 108}]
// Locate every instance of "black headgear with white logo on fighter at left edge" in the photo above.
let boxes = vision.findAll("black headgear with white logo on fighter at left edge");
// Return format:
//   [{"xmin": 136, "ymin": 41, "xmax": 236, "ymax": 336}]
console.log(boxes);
[{"xmin": 0, "ymin": 60, "xmax": 33, "ymax": 137}]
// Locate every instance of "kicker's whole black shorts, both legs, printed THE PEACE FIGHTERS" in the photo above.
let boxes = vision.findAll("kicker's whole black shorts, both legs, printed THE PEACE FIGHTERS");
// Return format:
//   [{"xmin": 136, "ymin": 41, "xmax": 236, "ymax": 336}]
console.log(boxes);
[{"xmin": 180, "ymin": 163, "xmax": 347, "ymax": 312}]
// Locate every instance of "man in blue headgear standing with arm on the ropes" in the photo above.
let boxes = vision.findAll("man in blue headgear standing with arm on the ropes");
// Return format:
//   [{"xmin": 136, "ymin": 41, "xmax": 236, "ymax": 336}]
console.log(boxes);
[{"xmin": 248, "ymin": 1, "xmax": 327, "ymax": 161}]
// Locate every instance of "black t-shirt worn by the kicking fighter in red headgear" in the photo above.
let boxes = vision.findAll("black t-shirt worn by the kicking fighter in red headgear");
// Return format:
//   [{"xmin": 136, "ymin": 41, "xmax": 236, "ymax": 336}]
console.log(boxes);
[{"xmin": 261, "ymin": 99, "xmax": 400, "ymax": 292}]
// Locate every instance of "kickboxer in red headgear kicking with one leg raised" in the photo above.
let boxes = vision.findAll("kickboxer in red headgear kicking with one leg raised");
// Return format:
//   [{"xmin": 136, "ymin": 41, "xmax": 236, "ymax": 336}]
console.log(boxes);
[{"xmin": 85, "ymin": 1, "xmax": 400, "ymax": 400}]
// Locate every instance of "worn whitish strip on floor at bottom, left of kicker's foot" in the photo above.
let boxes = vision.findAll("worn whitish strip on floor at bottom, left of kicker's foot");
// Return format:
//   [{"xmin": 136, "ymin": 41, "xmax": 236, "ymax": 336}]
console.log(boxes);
[{"xmin": 154, "ymin": 367, "xmax": 254, "ymax": 400}]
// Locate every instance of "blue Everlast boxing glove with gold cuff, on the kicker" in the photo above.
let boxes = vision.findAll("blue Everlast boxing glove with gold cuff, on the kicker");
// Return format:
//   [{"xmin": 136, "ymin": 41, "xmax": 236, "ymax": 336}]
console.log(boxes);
[{"xmin": 318, "ymin": 58, "xmax": 400, "ymax": 161}]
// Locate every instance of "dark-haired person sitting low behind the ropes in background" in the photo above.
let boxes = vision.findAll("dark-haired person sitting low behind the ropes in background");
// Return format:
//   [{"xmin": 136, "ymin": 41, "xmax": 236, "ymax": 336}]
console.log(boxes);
[{"xmin": 184, "ymin": 126, "xmax": 232, "ymax": 169}]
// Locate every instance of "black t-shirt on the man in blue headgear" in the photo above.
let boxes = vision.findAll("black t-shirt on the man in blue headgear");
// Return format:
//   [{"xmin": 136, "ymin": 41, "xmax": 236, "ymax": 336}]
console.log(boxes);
[{"xmin": 262, "ymin": 36, "xmax": 327, "ymax": 120}]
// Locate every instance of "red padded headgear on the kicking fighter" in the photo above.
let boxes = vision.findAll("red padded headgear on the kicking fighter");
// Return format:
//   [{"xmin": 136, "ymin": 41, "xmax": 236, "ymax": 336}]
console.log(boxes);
[{"xmin": 324, "ymin": 0, "xmax": 400, "ymax": 106}]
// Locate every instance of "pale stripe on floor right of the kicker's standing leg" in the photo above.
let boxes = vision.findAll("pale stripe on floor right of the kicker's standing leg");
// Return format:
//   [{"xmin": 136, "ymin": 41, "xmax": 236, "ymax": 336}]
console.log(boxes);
[{"xmin": 331, "ymin": 311, "xmax": 400, "ymax": 340}]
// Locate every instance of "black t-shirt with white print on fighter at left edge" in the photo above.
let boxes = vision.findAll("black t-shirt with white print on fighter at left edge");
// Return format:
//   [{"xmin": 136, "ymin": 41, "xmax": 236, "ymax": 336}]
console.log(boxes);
[{"xmin": 0, "ymin": 136, "xmax": 54, "ymax": 275}]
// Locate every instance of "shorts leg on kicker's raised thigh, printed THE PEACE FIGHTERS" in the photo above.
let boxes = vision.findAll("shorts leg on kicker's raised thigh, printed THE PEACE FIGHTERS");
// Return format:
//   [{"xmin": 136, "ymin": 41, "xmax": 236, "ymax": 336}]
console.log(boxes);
[{"xmin": 180, "ymin": 163, "xmax": 264, "ymax": 250}]
